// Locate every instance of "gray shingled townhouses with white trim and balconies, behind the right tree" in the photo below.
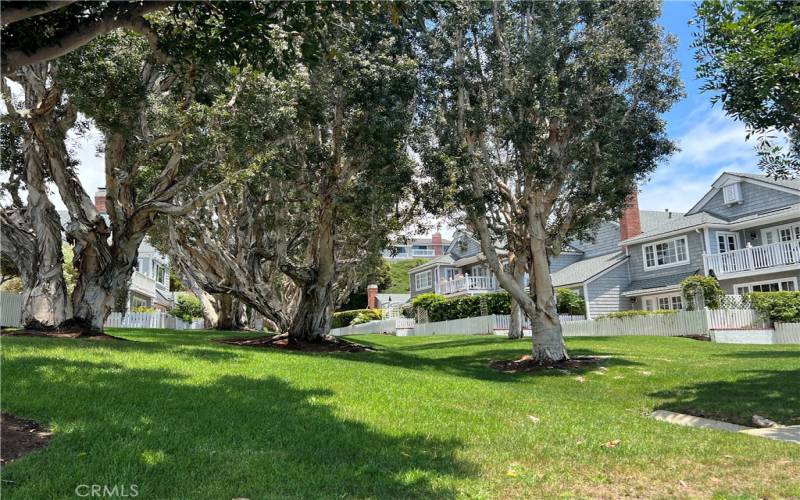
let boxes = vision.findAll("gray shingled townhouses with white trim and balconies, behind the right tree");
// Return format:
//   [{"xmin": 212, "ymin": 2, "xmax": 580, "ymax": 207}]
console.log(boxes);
[{"xmin": 409, "ymin": 172, "xmax": 800, "ymax": 317}]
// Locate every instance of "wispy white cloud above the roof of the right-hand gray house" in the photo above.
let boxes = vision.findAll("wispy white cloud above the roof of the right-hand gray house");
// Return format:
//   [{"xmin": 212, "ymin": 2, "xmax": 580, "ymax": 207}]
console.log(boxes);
[{"xmin": 639, "ymin": 108, "xmax": 759, "ymax": 212}]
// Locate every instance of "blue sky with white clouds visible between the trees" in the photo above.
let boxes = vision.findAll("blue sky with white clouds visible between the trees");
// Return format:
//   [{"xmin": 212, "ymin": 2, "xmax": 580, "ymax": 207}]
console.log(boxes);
[{"xmin": 67, "ymin": 1, "xmax": 759, "ymax": 219}]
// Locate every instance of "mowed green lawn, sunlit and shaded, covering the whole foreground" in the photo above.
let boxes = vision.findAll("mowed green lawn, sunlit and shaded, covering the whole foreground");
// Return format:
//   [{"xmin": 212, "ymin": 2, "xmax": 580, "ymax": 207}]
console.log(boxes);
[{"xmin": 2, "ymin": 330, "xmax": 800, "ymax": 500}]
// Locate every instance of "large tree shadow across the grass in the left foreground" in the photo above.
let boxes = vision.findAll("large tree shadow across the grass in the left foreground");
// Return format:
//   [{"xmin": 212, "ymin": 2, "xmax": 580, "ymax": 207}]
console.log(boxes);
[{"xmin": 3, "ymin": 356, "xmax": 472, "ymax": 498}]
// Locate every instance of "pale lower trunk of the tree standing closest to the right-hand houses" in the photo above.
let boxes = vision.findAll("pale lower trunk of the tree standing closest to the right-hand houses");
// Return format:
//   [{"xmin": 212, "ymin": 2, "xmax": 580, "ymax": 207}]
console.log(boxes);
[{"xmin": 529, "ymin": 222, "xmax": 569, "ymax": 363}]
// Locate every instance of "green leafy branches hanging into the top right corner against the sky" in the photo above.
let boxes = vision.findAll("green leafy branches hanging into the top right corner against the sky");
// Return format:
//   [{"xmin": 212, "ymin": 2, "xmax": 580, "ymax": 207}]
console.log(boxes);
[{"xmin": 693, "ymin": 0, "xmax": 800, "ymax": 176}]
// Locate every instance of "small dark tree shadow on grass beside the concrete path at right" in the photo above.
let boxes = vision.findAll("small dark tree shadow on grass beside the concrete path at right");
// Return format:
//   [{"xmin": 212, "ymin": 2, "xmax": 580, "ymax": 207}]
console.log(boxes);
[{"xmin": 650, "ymin": 369, "xmax": 800, "ymax": 426}]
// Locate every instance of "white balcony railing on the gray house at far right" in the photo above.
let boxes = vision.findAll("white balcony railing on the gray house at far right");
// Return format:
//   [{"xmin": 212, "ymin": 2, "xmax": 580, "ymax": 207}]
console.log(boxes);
[{"xmin": 703, "ymin": 241, "xmax": 800, "ymax": 276}]
